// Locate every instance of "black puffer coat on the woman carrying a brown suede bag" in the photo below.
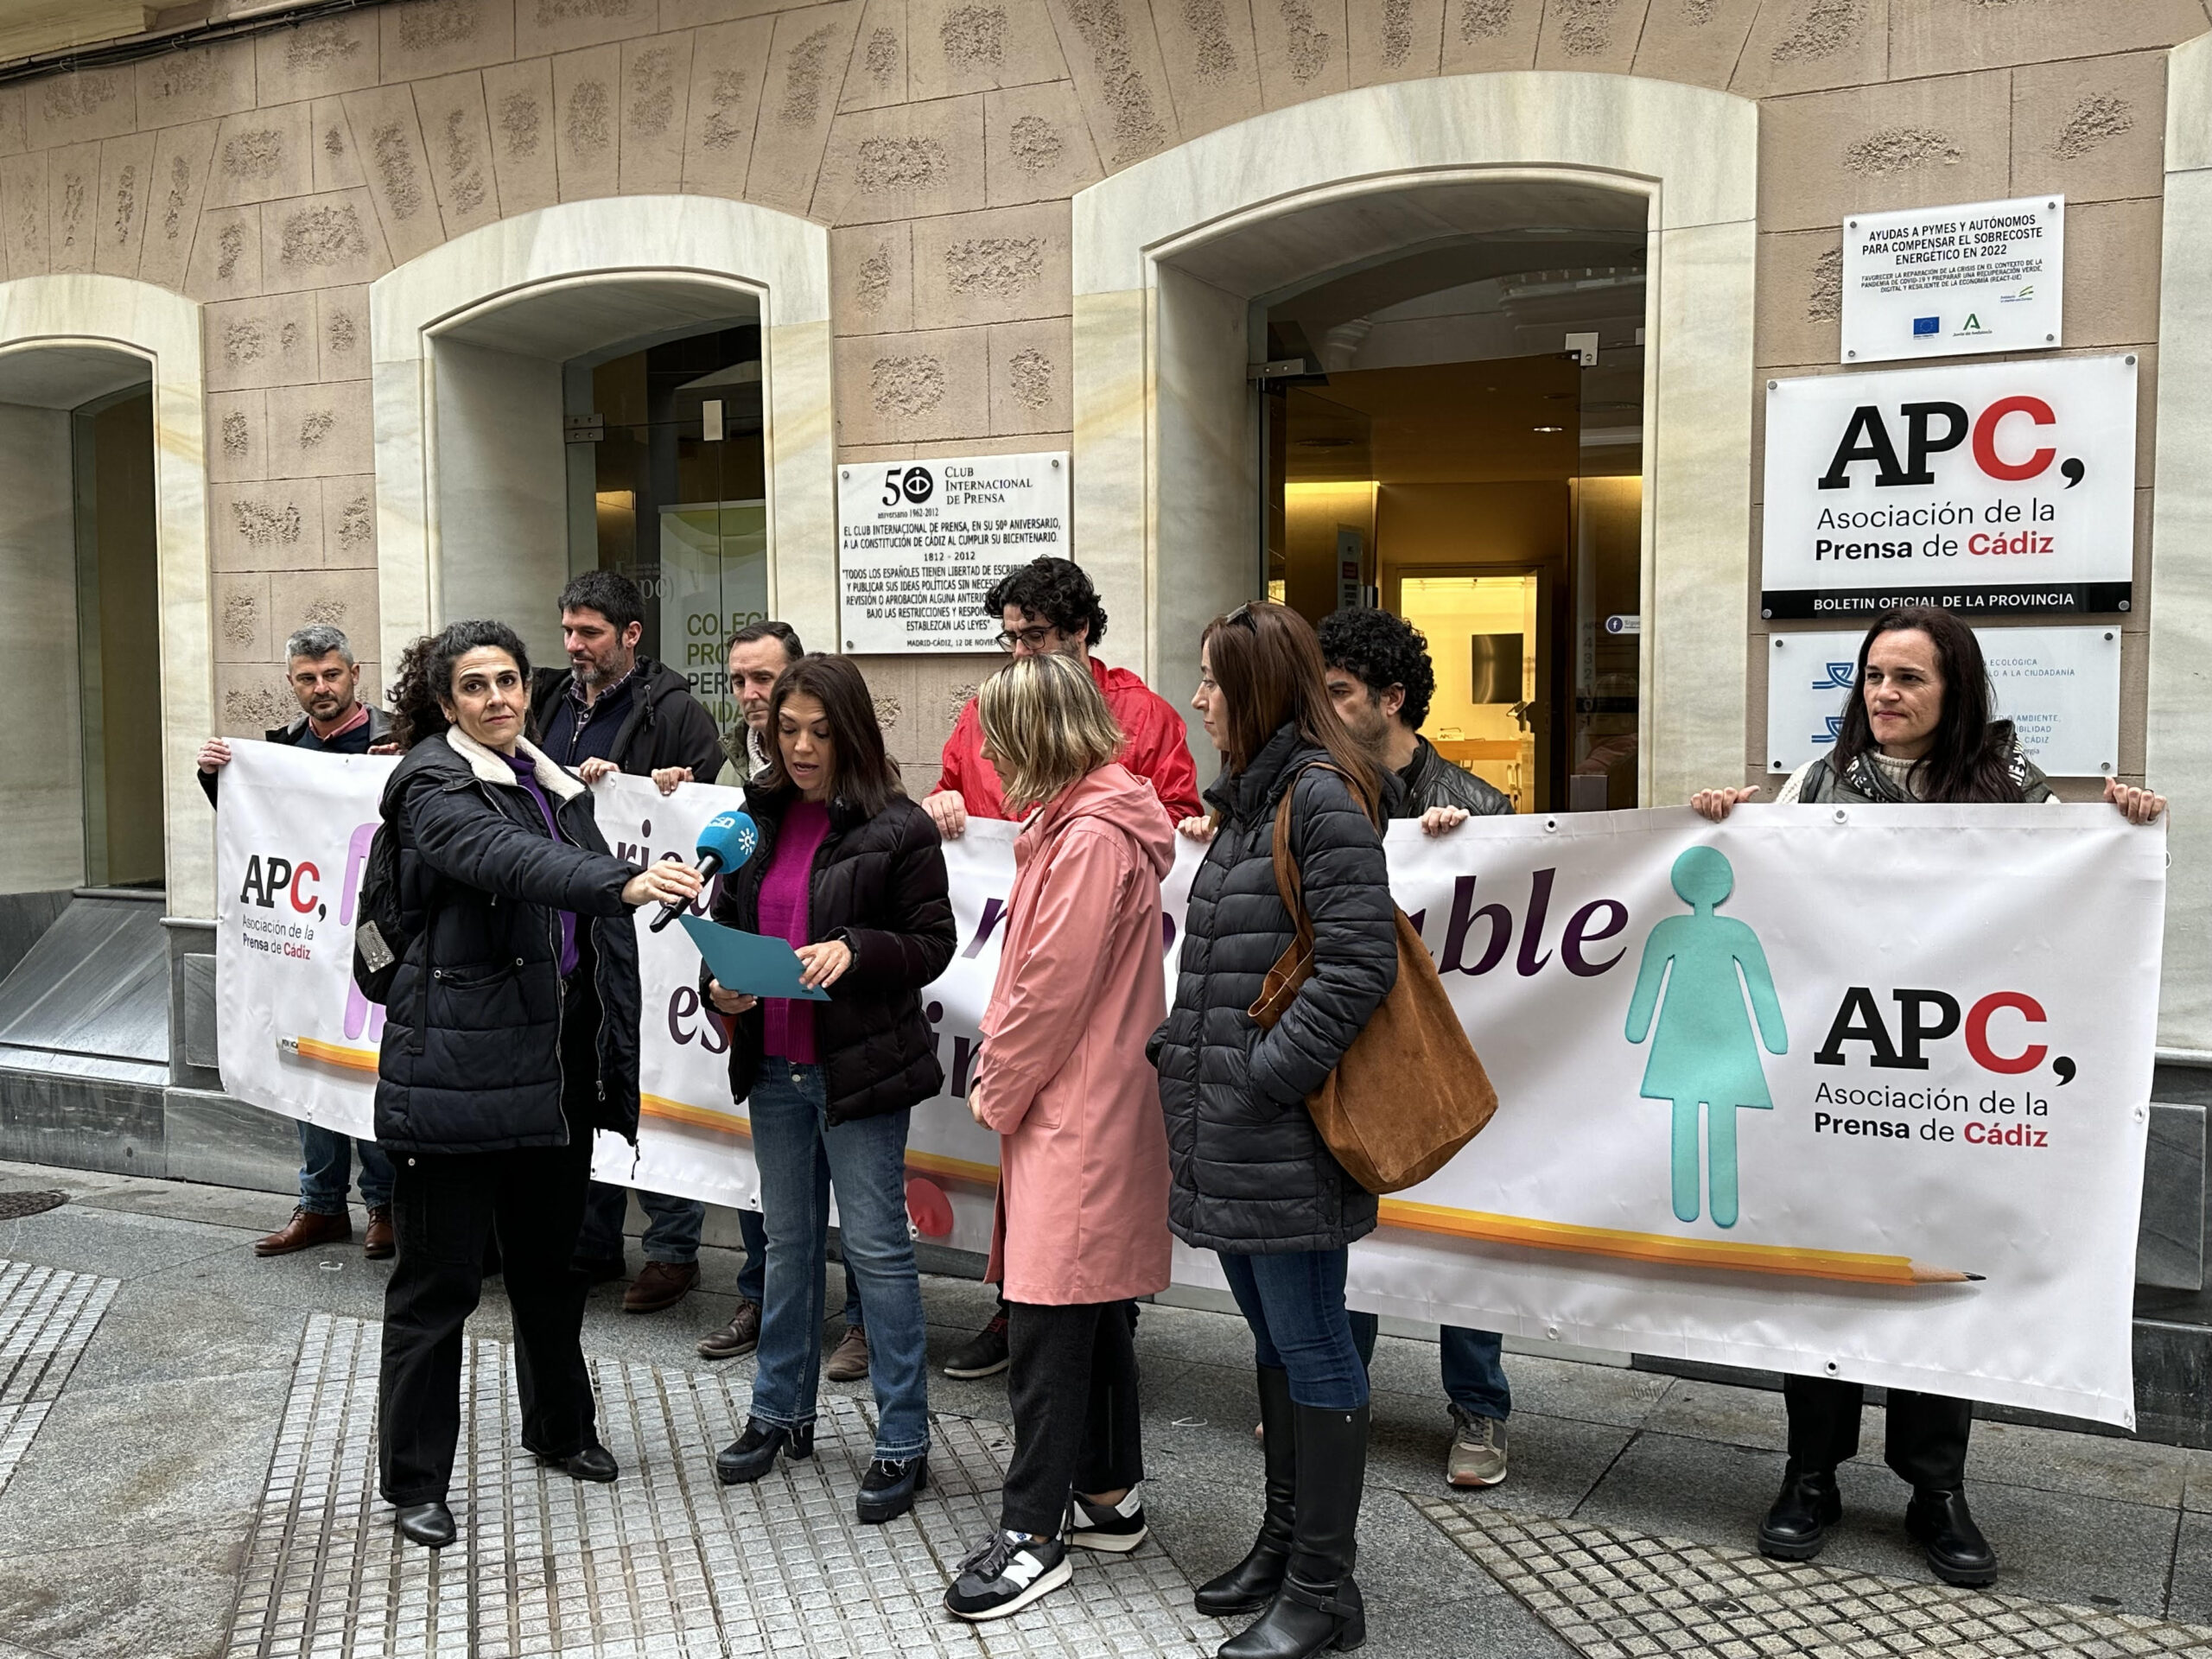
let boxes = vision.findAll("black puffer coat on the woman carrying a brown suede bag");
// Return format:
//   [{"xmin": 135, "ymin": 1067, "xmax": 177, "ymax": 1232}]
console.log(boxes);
[{"xmin": 1148, "ymin": 726, "xmax": 1398, "ymax": 1255}]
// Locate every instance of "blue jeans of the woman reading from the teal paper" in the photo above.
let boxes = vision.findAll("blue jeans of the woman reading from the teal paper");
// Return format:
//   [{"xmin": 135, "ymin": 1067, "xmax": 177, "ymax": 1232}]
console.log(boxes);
[{"xmin": 747, "ymin": 1055, "xmax": 929, "ymax": 1460}]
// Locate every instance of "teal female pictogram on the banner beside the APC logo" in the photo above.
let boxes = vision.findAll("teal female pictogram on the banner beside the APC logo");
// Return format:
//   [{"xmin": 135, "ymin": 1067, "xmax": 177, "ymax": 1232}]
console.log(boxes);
[{"xmin": 1628, "ymin": 847, "xmax": 1789, "ymax": 1228}]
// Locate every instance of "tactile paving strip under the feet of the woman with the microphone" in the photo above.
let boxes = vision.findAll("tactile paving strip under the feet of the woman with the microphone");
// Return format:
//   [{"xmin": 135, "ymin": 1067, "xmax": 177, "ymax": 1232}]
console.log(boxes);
[{"xmin": 228, "ymin": 1314, "xmax": 1230, "ymax": 1659}]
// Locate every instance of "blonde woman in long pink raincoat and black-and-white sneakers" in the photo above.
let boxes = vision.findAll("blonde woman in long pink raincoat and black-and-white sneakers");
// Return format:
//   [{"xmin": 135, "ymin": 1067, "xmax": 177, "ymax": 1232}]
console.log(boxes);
[{"xmin": 944, "ymin": 655, "xmax": 1174, "ymax": 1621}]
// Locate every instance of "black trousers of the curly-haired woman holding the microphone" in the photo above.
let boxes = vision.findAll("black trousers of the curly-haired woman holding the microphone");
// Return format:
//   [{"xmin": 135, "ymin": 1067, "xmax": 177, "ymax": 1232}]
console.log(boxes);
[{"xmin": 376, "ymin": 1135, "xmax": 597, "ymax": 1504}]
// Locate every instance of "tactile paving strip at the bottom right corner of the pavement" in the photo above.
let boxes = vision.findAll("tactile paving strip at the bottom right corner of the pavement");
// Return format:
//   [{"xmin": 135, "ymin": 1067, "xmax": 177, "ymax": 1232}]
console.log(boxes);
[{"xmin": 1414, "ymin": 1497, "xmax": 2212, "ymax": 1659}]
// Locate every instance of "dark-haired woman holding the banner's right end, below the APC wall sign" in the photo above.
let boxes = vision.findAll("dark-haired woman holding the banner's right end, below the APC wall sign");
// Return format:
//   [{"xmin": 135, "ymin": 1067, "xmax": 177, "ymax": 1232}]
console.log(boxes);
[{"xmin": 1690, "ymin": 606, "xmax": 2165, "ymax": 1586}]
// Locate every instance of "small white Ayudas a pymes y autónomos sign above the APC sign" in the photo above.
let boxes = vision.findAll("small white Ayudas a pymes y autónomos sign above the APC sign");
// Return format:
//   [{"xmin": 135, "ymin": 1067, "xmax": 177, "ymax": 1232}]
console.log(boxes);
[{"xmin": 1842, "ymin": 197, "xmax": 2066, "ymax": 363}]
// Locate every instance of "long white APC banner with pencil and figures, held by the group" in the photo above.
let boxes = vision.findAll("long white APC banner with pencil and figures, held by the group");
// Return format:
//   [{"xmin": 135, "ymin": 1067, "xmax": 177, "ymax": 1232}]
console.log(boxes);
[{"xmin": 217, "ymin": 743, "xmax": 2165, "ymax": 1425}]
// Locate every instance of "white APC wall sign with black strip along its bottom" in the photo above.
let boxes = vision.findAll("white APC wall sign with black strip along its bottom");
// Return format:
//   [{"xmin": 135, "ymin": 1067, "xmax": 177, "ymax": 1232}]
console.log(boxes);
[{"xmin": 1758, "ymin": 354, "xmax": 2134, "ymax": 620}]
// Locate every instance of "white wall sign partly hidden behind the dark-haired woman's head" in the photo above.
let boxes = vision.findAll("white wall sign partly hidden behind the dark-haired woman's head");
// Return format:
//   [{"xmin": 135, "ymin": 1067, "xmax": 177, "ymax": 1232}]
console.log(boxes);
[{"xmin": 1767, "ymin": 628, "xmax": 2119, "ymax": 779}]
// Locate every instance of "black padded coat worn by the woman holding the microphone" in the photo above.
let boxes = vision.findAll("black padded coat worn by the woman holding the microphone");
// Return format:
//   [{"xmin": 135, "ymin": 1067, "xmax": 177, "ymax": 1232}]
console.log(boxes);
[{"xmin": 376, "ymin": 730, "xmax": 639, "ymax": 1153}]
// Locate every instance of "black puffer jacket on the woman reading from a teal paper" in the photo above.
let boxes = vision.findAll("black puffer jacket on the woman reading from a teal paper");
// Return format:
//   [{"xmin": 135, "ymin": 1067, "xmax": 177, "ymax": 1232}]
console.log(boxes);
[{"xmin": 699, "ymin": 785, "xmax": 960, "ymax": 1123}]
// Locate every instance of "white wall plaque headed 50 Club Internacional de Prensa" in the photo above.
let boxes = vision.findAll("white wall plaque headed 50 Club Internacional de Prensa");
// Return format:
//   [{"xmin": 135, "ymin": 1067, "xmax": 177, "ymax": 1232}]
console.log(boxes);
[{"xmin": 836, "ymin": 449, "xmax": 1068, "ymax": 652}]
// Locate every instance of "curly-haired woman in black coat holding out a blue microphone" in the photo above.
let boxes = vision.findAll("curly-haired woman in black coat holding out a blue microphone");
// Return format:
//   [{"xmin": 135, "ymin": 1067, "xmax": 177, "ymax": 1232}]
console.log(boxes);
[{"xmin": 376, "ymin": 621, "xmax": 699, "ymax": 1548}]
